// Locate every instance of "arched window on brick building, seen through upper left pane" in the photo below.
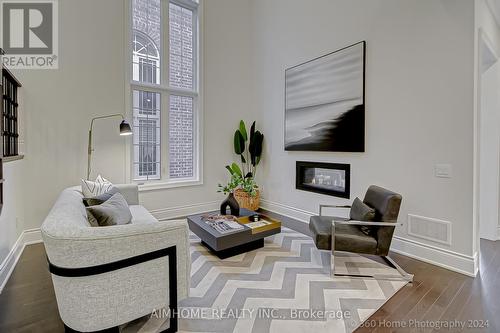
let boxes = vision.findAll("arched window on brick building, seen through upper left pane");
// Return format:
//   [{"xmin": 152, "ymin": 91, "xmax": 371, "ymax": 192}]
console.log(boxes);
[{"xmin": 132, "ymin": 30, "xmax": 160, "ymax": 84}]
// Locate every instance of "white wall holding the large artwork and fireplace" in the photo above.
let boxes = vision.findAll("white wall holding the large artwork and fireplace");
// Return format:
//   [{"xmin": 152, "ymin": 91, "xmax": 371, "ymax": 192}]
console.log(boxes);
[{"xmin": 252, "ymin": 0, "xmax": 474, "ymax": 272}]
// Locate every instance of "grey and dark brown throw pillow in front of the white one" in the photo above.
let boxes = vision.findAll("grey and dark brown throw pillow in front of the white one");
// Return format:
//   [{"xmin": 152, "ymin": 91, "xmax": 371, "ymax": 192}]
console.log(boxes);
[{"xmin": 86, "ymin": 193, "xmax": 132, "ymax": 227}]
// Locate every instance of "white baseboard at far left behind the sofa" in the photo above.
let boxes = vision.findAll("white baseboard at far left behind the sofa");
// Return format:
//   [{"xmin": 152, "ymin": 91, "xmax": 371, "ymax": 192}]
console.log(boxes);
[{"xmin": 0, "ymin": 228, "xmax": 42, "ymax": 293}]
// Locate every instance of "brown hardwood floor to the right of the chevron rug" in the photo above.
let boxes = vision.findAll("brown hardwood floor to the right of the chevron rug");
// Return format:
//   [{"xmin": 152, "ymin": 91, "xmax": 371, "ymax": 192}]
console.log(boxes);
[{"xmin": 356, "ymin": 240, "xmax": 500, "ymax": 333}]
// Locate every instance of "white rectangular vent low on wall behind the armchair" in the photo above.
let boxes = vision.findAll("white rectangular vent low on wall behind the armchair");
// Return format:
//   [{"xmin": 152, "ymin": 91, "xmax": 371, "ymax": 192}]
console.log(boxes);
[{"xmin": 408, "ymin": 214, "xmax": 451, "ymax": 245}]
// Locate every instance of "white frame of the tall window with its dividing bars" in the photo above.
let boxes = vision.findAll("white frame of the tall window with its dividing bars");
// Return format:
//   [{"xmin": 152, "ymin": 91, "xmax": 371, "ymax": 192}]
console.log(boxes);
[{"xmin": 125, "ymin": 0, "xmax": 203, "ymax": 191}]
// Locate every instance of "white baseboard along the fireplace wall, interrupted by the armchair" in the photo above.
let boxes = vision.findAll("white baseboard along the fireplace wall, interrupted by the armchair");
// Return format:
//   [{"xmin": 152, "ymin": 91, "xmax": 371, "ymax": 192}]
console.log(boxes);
[{"xmin": 260, "ymin": 199, "xmax": 478, "ymax": 277}]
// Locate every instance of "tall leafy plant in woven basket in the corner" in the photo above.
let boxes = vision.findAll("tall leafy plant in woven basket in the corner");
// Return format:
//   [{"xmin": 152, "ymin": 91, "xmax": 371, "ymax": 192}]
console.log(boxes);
[{"xmin": 218, "ymin": 120, "xmax": 264, "ymax": 210}]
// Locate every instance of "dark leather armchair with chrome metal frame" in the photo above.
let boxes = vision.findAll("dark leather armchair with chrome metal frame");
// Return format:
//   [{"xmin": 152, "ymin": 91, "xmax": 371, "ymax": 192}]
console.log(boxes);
[{"xmin": 309, "ymin": 185, "xmax": 413, "ymax": 281}]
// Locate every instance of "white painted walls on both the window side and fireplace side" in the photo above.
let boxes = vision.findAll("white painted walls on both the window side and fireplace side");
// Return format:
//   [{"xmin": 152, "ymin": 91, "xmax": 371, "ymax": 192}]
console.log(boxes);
[{"xmin": 0, "ymin": 0, "xmax": 484, "ymax": 274}]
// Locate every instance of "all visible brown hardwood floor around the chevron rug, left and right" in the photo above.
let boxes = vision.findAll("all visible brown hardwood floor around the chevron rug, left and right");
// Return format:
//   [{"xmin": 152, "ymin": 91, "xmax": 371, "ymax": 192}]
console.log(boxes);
[{"xmin": 0, "ymin": 214, "xmax": 500, "ymax": 333}]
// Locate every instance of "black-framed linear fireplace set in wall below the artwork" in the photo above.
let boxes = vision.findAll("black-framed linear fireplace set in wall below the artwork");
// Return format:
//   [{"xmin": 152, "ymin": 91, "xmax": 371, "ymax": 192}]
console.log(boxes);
[{"xmin": 295, "ymin": 161, "xmax": 351, "ymax": 199}]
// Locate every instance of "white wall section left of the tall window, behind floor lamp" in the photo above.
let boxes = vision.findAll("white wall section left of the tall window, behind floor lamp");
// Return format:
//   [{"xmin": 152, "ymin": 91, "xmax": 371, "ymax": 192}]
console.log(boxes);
[{"xmin": 11, "ymin": 0, "xmax": 129, "ymax": 229}]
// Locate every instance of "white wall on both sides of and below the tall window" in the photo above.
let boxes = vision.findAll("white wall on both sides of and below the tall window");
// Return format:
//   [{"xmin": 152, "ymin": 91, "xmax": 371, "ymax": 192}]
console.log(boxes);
[{"xmin": 9, "ymin": 0, "xmax": 251, "ymax": 229}]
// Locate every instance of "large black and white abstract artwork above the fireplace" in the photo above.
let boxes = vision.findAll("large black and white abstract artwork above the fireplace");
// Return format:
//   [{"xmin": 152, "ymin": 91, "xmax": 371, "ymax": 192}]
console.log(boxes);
[{"xmin": 285, "ymin": 41, "xmax": 366, "ymax": 152}]
